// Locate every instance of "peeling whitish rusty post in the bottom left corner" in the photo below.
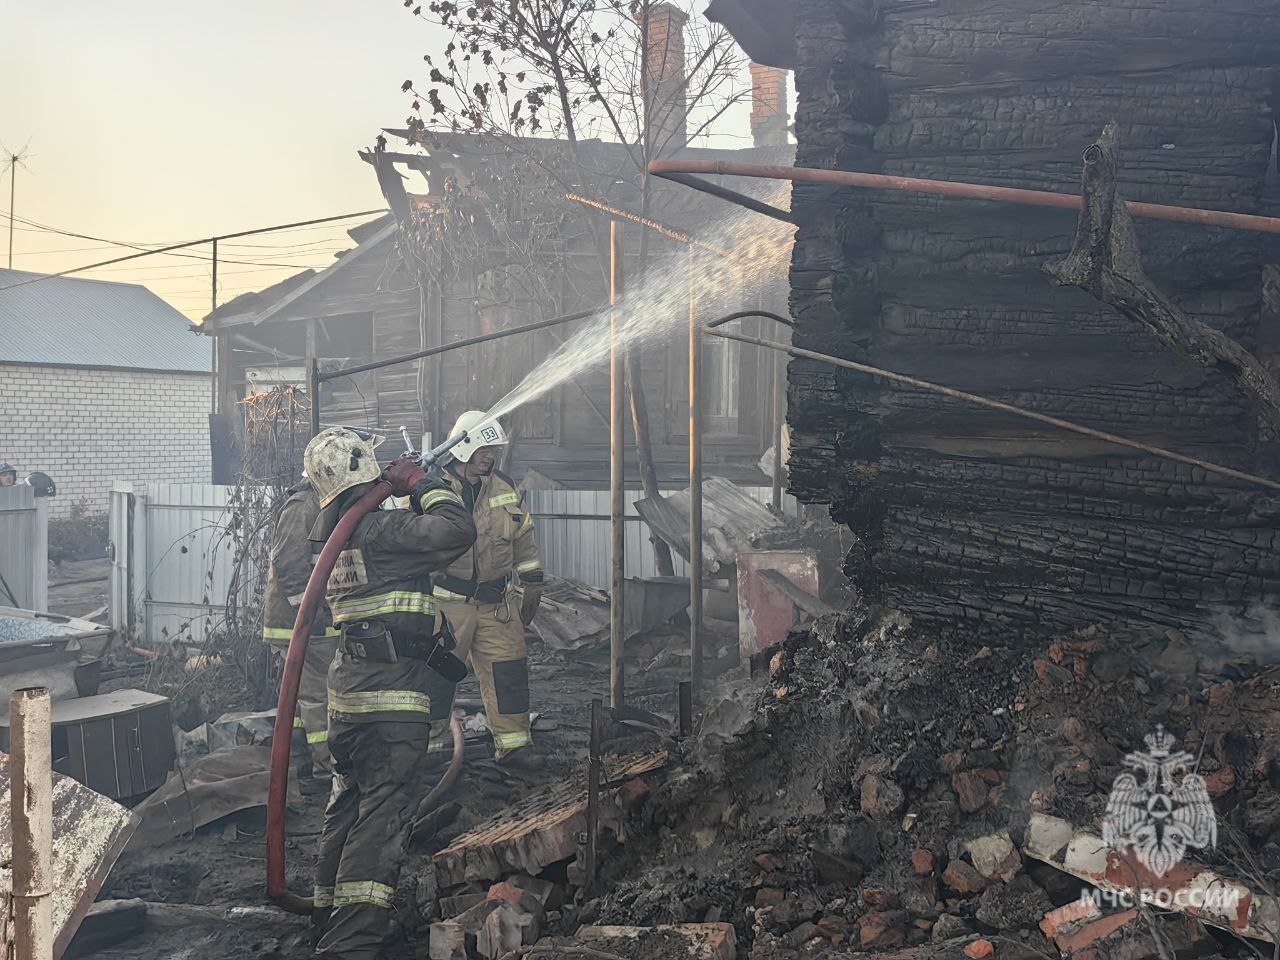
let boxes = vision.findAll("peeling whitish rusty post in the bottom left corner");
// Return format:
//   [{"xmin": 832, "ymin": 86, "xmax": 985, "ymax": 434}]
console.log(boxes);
[{"xmin": 9, "ymin": 687, "xmax": 54, "ymax": 960}]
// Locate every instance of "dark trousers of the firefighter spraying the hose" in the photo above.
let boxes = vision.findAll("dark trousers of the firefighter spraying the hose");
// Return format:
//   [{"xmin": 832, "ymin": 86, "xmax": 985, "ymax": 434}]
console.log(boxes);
[{"xmin": 315, "ymin": 718, "xmax": 431, "ymax": 960}]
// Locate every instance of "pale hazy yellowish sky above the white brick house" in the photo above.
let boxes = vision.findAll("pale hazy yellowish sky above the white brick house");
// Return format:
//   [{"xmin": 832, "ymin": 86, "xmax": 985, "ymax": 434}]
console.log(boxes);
[{"xmin": 0, "ymin": 0, "xmax": 748, "ymax": 319}]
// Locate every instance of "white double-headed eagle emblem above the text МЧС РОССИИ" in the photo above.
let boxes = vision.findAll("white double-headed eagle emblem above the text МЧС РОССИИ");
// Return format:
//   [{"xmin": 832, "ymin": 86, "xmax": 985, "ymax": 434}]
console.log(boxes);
[{"xmin": 1102, "ymin": 726, "xmax": 1217, "ymax": 877}]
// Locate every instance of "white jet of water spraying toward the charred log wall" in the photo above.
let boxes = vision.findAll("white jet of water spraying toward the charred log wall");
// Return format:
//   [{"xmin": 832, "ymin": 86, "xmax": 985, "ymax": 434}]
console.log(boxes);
[{"xmin": 489, "ymin": 192, "xmax": 795, "ymax": 417}]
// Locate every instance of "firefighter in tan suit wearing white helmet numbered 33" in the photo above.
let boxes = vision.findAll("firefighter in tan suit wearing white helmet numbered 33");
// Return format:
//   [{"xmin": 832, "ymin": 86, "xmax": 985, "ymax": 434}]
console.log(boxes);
[{"xmin": 434, "ymin": 410, "xmax": 543, "ymax": 765}]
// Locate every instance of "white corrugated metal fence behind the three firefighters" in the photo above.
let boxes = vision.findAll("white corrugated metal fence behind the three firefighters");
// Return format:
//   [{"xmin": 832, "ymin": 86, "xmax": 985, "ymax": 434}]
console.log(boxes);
[{"xmin": 109, "ymin": 483, "xmax": 797, "ymax": 644}]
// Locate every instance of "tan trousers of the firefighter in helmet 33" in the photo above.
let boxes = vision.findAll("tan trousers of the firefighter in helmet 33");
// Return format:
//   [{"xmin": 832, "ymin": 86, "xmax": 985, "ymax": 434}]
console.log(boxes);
[{"xmin": 438, "ymin": 593, "xmax": 532, "ymax": 758}]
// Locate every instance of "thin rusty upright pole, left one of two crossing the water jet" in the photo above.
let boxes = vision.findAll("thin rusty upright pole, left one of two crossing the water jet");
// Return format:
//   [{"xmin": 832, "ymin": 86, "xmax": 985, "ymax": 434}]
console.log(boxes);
[{"xmin": 609, "ymin": 220, "xmax": 627, "ymax": 708}]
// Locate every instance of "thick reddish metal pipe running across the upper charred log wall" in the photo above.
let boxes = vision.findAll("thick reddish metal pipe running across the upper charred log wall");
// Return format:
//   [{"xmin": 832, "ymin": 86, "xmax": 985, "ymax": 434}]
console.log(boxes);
[{"xmin": 649, "ymin": 160, "xmax": 1280, "ymax": 233}]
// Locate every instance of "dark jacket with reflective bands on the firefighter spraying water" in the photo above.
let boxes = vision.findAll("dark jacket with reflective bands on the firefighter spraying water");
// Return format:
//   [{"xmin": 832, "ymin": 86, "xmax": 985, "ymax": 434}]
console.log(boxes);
[{"xmin": 328, "ymin": 488, "xmax": 476, "ymax": 732}]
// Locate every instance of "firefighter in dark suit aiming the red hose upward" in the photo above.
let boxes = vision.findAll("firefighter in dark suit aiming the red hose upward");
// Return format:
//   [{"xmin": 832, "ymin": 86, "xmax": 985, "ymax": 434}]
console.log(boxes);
[{"xmin": 303, "ymin": 428, "xmax": 476, "ymax": 960}]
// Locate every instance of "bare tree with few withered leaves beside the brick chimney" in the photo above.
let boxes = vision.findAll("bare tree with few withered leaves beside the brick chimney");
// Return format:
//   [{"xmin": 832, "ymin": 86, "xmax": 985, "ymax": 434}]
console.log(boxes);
[{"xmin": 389, "ymin": 0, "xmax": 750, "ymax": 576}]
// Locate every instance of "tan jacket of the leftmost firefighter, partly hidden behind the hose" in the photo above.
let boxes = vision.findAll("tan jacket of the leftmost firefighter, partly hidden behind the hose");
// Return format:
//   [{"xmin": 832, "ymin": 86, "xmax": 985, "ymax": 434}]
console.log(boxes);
[{"xmin": 262, "ymin": 480, "xmax": 338, "ymax": 644}]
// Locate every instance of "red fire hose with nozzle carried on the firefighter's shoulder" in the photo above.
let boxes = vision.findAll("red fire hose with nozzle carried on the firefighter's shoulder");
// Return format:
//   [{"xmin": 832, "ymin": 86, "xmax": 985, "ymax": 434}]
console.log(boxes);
[{"xmin": 266, "ymin": 433, "xmax": 467, "ymax": 916}]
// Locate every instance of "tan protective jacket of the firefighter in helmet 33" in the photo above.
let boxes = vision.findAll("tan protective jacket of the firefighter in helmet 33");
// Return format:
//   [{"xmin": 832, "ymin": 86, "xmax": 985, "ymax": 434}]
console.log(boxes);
[{"xmin": 435, "ymin": 463, "xmax": 543, "ymax": 603}]
